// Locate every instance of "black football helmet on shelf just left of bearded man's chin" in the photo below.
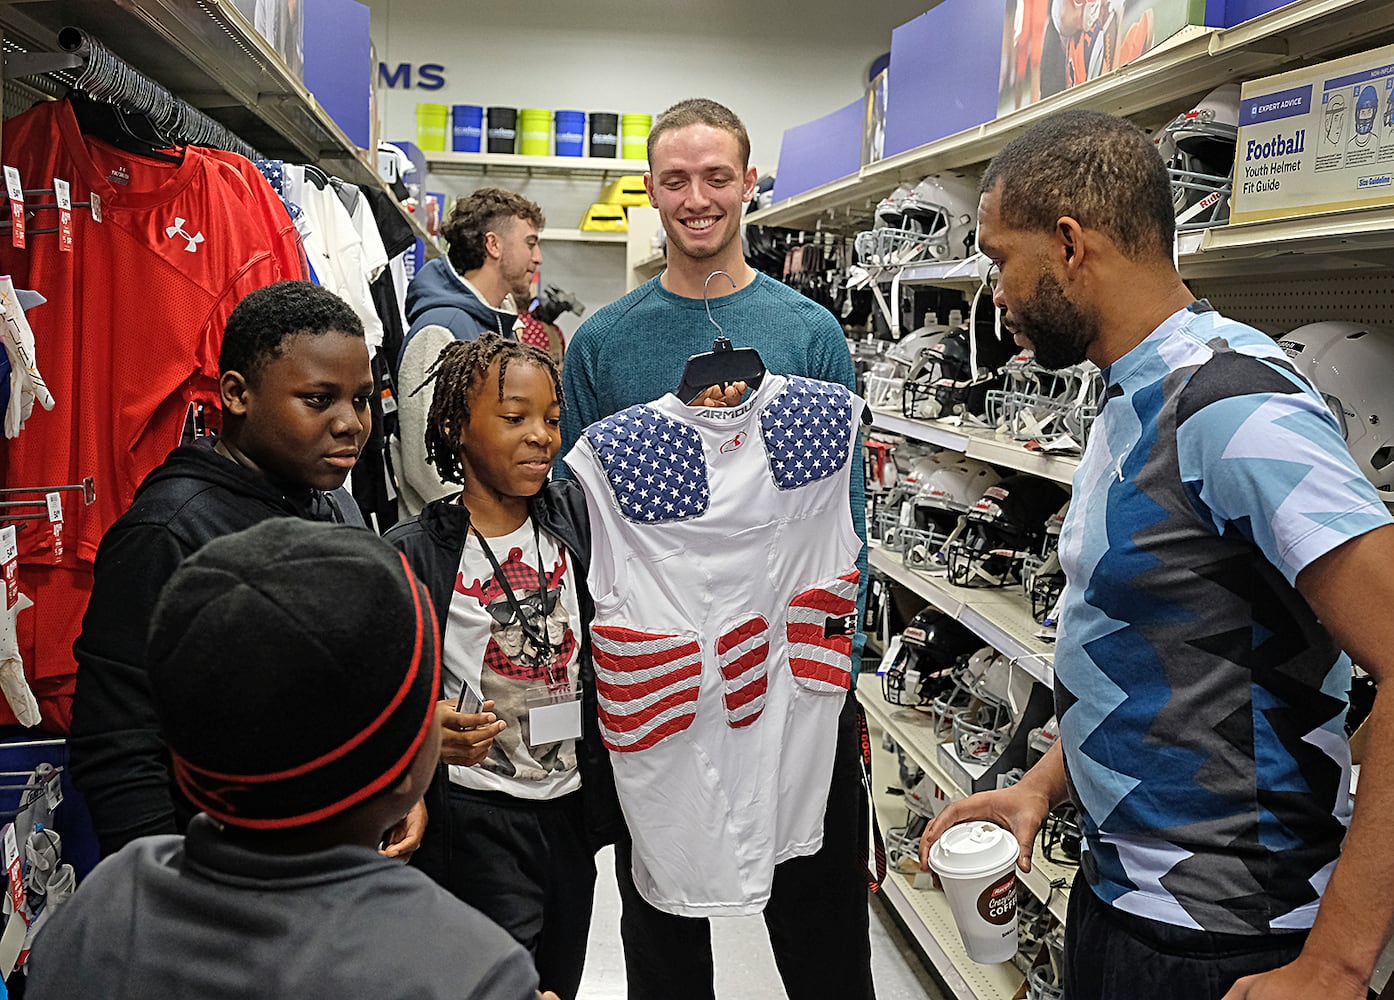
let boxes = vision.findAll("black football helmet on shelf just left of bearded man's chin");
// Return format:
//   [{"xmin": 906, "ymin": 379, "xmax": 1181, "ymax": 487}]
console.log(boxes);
[{"xmin": 902, "ymin": 325, "xmax": 1015, "ymax": 420}]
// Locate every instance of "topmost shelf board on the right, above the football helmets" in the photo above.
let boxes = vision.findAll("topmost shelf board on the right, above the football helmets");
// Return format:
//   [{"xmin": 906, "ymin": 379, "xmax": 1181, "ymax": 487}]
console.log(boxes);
[{"xmin": 749, "ymin": 0, "xmax": 1394, "ymax": 233}]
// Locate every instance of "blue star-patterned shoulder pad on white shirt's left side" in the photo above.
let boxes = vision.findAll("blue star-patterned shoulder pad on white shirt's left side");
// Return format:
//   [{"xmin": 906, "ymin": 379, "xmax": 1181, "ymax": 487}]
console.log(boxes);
[{"xmin": 585, "ymin": 406, "xmax": 711, "ymax": 524}]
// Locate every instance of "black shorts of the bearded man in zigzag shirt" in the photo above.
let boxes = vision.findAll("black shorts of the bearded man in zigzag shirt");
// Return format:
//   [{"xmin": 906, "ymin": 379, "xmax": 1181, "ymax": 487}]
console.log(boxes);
[{"xmin": 1064, "ymin": 876, "xmax": 1308, "ymax": 1000}]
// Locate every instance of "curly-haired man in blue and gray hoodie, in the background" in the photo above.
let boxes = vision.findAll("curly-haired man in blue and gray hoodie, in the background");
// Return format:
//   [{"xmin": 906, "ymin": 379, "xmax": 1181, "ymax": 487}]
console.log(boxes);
[{"xmin": 392, "ymin": 187, "xmax": 546, "ymax": 516}]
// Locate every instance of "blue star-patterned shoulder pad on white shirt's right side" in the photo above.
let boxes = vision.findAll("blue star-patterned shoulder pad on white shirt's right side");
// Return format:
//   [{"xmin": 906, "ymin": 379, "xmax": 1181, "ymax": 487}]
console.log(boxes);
[{"xmin": 760, "ymin": 375, "xmax": 852, "ymax": 490}]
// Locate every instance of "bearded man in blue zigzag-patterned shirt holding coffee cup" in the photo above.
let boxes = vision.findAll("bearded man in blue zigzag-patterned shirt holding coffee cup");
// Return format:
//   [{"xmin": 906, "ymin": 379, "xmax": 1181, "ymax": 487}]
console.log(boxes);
[{"xmin": 921, "ymin": 105, "xmax": 1394, "ymax": 1000}]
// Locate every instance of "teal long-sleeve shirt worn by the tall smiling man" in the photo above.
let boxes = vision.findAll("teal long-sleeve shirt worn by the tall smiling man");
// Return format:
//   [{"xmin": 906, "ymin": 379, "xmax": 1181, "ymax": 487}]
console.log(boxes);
[{"xmin": 556, "ymin": 273, "xmax": 867, "ymax": 685}]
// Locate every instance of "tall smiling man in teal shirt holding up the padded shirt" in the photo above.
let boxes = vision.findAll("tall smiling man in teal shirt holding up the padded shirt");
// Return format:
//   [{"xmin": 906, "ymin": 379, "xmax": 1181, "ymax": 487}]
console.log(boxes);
[{"xmin": 560, "ymin": 99, "xmax": 873, "ymax": 1000}]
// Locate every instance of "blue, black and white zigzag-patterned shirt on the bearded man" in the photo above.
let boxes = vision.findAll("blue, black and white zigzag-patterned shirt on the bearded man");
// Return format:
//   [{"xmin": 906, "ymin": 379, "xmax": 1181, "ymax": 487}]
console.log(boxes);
[{"xmin": 1055, "ymin": 303, "xmax": 1390, "ymax": 934}]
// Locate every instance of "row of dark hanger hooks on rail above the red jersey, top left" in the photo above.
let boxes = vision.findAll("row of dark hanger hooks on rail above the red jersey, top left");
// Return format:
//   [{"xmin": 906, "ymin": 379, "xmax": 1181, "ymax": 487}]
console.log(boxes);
[{"xmin": 59, "ymin": 26, "xmax": 261, "ymax": 159}]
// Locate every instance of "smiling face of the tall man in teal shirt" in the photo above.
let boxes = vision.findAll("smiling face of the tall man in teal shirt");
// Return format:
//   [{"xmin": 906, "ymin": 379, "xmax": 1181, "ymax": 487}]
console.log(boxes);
[{"xmin": 644, "ymin": 124, "xmax": 756, "ymax": 261}]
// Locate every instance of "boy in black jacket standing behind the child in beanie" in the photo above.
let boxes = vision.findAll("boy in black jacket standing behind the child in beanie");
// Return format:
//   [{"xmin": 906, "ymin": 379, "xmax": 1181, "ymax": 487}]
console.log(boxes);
[{"xmin": 68, "ymin": 282, "xmax": 398, "ymax": 856}]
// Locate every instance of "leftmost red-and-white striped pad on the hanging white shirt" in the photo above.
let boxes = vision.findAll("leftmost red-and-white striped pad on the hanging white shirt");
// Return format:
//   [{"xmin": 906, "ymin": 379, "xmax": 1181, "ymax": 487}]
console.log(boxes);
[{"xmin": 591, "ymin": 625, "xmax": 701, "ymax": 753}]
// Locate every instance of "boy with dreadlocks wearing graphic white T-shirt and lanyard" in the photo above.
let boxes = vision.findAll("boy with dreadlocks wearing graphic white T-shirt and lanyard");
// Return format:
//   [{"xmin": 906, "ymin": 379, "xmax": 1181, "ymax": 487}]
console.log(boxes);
[{"xmin": 386, "ymin": 333, "xmax": 620, "ymax": 997}]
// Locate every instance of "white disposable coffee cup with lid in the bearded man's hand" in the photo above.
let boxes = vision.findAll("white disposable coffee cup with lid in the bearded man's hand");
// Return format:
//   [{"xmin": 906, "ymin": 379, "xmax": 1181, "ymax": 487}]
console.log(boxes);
[{"xmin": 930, "ymin": 821, "xmax": 1020, "ymax": 964}]
